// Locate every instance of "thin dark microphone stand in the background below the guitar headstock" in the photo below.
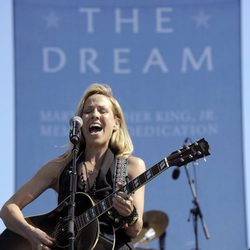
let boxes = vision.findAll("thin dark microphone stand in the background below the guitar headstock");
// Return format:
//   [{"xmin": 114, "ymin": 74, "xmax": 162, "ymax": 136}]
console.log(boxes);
[{"xmin": 184, "ymin": 165, "xmax": 210, "ymax": 250}]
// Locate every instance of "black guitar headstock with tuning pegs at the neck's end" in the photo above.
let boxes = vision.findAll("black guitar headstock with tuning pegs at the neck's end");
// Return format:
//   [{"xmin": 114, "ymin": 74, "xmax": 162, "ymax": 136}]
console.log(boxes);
[{"xmin": 167, "ymin": 138, "xmax": 210, "ymax": 167}]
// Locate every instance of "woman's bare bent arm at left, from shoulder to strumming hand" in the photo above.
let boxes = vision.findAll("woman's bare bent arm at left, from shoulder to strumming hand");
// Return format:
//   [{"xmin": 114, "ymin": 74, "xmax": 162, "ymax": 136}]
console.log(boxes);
[{"xmin": 0, "ymin": 161, "xmax": 59, "ymax": 249}]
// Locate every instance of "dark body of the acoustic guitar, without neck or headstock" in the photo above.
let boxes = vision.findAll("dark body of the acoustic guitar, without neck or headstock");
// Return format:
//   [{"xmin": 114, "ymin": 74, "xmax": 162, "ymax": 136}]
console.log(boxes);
[{"xmin": 0, "ymin": 193, "xmax": 115, "ymax": 250}]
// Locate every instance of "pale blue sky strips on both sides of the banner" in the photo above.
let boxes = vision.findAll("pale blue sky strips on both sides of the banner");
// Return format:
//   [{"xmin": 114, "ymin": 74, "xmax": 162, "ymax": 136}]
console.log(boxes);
[{"xmin": 0, "ymin": 0, "xmax": 250, "ymax": 247}]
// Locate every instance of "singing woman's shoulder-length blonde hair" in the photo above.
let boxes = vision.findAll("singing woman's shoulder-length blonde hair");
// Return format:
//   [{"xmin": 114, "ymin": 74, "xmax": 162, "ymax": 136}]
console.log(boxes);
[{"xmin": 57, "ymin": 83, "xmax": 134, "ymax": 160}]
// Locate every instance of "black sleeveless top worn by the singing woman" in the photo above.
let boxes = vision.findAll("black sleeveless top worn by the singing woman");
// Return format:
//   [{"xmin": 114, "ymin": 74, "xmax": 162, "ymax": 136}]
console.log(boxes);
[{"xmin": 58, "ymin": 149, "xmax": 134, "ymax": 250}]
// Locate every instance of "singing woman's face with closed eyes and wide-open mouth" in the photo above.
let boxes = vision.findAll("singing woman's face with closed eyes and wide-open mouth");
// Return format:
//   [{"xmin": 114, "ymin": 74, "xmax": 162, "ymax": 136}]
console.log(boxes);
[{"xmin": 82, "ymin": 94, "xmax": 119, "ymax": 147}]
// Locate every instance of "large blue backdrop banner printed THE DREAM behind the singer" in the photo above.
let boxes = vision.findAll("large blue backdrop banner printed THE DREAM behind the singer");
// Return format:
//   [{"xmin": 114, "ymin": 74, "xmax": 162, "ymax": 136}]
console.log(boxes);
[{"xmin": 14, "ymin": 0, "xmax": 247, "ymax": 250}]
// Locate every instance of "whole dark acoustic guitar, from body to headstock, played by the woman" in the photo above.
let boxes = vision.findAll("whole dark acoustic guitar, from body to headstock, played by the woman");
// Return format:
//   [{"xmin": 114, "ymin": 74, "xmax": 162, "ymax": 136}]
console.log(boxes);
[{"xmin": 0, "ymin": 138, "xmax": 210, "ymax": 250}]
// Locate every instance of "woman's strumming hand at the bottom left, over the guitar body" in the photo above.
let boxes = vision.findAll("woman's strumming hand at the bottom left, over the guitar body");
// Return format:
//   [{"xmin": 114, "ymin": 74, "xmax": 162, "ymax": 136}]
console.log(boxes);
[{"xmin": 28, "ymin": 227, "xmax": 55, "ymax": 250}]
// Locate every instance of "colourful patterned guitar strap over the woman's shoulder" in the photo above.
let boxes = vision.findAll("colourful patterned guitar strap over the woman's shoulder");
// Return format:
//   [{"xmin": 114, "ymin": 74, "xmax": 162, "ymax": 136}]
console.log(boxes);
[{"xmin": 113, "ymin": 157, "xmax": 128, "ymax": 192}]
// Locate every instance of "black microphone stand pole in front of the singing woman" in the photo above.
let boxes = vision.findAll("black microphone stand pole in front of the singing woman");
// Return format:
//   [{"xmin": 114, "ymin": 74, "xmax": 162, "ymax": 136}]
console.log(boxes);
[{"xmin": 68, "ymin": 141, "xmax": 79, "ymax": 250}]
